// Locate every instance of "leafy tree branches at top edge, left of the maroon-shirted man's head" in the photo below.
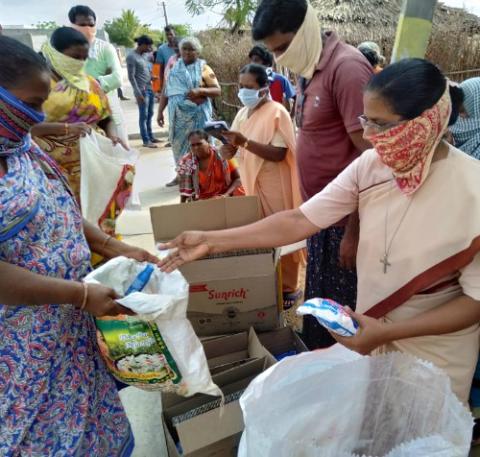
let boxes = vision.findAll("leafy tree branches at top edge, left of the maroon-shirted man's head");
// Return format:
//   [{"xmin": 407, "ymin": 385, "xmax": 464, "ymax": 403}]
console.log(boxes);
[{"xmin": 185, "ymin": 0, "xmax": 258, "ymax": 33}]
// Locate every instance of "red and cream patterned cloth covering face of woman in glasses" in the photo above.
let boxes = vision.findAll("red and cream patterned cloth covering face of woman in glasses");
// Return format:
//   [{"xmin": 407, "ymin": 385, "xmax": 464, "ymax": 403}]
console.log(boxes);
[{"xmin": 365, "ymin": 86, "xmax": 452, "ymax": 195}]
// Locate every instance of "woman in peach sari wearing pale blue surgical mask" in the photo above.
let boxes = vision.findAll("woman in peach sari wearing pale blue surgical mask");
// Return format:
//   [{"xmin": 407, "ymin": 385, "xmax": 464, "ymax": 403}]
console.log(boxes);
[{"xmin": 221, "ymin": 64, "xmax": 304, "ymax": 309}]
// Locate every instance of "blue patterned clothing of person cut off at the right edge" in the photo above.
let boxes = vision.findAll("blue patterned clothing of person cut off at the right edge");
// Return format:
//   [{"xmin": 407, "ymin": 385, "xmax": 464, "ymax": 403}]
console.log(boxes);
[{"xmin": 451, "ymin": 78, "xmax": 480, "ymax": 159}]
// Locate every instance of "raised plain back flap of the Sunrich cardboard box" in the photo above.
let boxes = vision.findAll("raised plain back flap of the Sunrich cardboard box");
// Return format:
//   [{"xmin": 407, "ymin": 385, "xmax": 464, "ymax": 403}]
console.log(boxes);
[{"xmin": 150, "ymin": 197, "xmax": 261, "ymax": 242}]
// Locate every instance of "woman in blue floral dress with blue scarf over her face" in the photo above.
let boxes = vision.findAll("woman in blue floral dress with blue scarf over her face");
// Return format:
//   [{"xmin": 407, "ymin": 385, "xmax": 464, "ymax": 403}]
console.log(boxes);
[{"xmin": 0, "ymin": 37, "xmax": 161, "ymax": 457}]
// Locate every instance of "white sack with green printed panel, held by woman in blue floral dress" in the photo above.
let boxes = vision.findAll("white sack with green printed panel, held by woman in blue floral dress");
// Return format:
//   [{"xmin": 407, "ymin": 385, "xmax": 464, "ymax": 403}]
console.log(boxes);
[{"xmin": 85, "ymin": 257, "xmax": 222, "ymax": 396}]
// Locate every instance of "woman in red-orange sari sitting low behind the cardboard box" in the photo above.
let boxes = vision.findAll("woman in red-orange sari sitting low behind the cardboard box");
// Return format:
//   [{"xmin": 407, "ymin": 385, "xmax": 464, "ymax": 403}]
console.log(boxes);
[{"xmin": 177, "ymin": 130, "xmax": 241, "ymax": 203}]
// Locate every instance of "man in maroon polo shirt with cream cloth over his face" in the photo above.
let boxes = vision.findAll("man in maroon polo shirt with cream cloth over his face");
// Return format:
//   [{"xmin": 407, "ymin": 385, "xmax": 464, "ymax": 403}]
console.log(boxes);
[{"xmin": 252, "ymin": 0, "xmax": 373, "ymax": 349}]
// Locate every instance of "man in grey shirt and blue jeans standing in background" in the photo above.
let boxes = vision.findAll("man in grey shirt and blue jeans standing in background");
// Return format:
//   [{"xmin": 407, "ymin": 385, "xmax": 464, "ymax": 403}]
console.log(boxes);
[{"xmin": 127, "ymin": 35, "xmax": 160, "ymax": 149}]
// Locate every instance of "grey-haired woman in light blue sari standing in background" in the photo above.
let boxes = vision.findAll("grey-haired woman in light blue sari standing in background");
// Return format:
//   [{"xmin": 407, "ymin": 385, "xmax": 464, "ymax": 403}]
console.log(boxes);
[{"xmin": 158, "ymin": 38, "xmax": 221, "ymax": 185}]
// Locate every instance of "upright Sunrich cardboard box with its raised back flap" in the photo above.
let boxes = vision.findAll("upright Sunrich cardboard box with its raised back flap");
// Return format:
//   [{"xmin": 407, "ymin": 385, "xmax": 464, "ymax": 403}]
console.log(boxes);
[{"xmin": 150, "ymin": 197, "xmax": 281, "ymax": 336}]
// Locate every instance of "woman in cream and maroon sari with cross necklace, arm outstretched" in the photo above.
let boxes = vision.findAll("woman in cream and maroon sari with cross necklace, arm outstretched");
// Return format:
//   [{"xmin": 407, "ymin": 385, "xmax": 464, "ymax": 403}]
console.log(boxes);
[{"xmin": 159, "ymin": 59, "xmax": 480, "ymax": 403}]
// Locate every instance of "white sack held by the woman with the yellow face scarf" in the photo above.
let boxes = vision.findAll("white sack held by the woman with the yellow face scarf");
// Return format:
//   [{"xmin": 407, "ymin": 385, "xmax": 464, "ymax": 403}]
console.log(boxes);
[{"xmin": 80, "ymin": 130, "xmax": 138, "ymax": 226}]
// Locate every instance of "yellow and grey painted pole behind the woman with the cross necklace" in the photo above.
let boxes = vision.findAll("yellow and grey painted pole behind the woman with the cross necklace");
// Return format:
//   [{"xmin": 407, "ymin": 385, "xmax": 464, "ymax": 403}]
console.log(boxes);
[{"xmin": 392, "ymin": 0, "xmax": 437, "ymax": 63}]
